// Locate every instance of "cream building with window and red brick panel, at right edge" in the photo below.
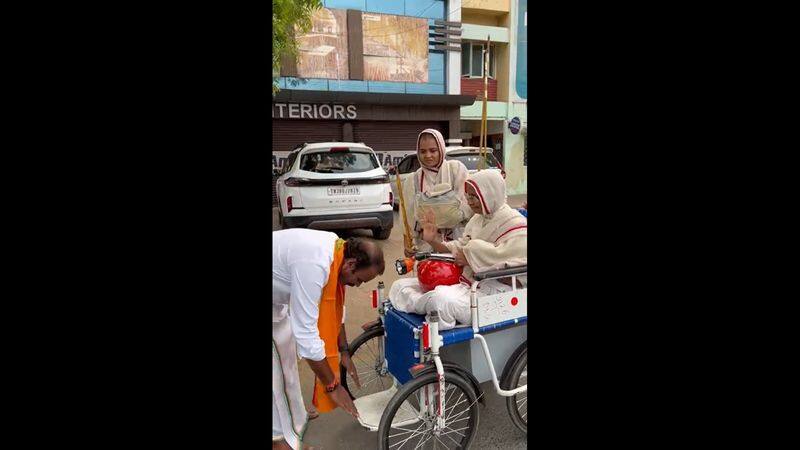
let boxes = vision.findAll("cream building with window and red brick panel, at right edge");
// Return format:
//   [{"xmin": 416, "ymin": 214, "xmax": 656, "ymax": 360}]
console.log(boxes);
[{"xmin": 454, "ymin": 0, "xmax": 528, "ymax": 195}]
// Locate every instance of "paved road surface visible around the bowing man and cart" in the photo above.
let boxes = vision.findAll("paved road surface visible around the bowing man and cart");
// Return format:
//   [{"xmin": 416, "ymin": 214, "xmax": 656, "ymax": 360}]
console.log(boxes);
[{"xmin": 272, "ymin": 196, "xmax": 527, "ymax": 450}]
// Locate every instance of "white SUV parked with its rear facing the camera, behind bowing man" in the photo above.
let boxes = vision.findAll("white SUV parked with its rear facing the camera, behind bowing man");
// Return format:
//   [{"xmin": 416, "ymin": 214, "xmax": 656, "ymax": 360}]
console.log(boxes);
[{"xmin": 276, "ymin": 142, "xmax": 394, "ymax": 239}]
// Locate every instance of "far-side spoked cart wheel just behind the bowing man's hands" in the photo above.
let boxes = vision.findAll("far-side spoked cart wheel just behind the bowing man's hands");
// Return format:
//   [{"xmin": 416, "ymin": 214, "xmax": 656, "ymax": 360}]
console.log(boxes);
[{"xmin": 339, "ymin": 326, "xmax": 393, "ymax": 400}]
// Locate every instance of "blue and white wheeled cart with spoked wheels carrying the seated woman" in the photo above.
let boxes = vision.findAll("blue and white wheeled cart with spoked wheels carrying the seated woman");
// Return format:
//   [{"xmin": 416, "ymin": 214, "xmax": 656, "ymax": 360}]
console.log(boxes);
[{"xmin": 340, "ymin": 253, "xmax": 528, "ymax": 450}]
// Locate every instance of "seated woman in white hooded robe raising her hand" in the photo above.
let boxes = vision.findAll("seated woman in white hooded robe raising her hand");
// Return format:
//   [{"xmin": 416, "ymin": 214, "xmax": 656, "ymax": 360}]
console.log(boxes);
[{"xmin": 389, "ymin": 170, "xmax": 528, "ymax": 330}]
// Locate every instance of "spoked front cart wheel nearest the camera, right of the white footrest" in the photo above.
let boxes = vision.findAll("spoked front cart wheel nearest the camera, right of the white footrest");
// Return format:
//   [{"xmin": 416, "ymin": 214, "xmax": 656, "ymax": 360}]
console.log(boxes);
[{"xmin": 378, "ymin": 372, "xmax": 480, "ymax": 450}]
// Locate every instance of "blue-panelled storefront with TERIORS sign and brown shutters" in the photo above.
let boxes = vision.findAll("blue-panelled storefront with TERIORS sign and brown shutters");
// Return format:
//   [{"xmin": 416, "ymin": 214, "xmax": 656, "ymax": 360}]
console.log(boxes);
[{"xmin": 272, "ymin": 0, "xmax": 475, "ymax": 173}]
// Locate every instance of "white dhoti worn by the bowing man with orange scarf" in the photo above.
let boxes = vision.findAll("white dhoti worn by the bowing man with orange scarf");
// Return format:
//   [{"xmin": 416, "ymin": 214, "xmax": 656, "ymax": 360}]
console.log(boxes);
[{"xmin": 272, "ymin": 317, "xmax": 308, "ymax": 450}]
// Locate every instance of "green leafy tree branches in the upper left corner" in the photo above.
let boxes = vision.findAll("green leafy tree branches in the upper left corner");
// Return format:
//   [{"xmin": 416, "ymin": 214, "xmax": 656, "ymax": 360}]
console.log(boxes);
[{"xmin": 272, "ymin": 0, "xmax": 322, "ymax": 94}]
